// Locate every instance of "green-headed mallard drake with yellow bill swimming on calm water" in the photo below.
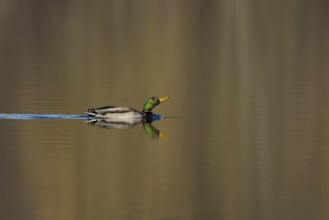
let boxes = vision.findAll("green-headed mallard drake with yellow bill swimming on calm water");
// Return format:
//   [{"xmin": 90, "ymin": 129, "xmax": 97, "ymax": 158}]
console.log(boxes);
[{"xmin": 86, "ymin": 96, "xmax": 170, "ymax": 122}]
